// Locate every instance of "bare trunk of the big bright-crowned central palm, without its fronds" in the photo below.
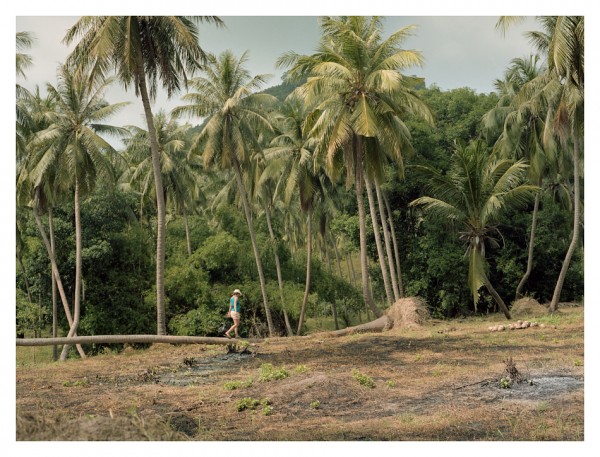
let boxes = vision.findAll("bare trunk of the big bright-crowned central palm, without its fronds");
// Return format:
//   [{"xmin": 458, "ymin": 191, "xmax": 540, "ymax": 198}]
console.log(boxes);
[{"xmin": 353, "ymin": 135, "xmax": 381, "ymax": 317}]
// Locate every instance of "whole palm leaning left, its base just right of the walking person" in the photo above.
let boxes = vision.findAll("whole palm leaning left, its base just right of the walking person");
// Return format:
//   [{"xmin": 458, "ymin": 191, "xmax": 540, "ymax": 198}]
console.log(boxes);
[{"xmin": 173, "ymin": 51, "xmax": 277, "ymax": 336}]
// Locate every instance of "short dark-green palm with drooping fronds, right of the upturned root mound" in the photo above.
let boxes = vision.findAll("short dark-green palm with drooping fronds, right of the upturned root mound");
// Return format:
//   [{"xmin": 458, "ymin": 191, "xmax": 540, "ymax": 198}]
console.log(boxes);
[{"xmin": 410, "ymin": 141, "xmax": 538, "ymax": 319}]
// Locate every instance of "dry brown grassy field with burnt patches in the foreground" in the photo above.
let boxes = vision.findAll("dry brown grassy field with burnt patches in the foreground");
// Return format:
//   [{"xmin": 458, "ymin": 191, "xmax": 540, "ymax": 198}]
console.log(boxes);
[{"xmin": 16, "ymin": 307, "xmax": 584, "ymax": 441}]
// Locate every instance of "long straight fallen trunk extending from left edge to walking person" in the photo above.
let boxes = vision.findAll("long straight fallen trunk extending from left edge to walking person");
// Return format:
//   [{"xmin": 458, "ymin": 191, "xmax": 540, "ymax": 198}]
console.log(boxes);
[{"xmin": 17, "ymin": 335, "xmax": 237, "ymax": 346}]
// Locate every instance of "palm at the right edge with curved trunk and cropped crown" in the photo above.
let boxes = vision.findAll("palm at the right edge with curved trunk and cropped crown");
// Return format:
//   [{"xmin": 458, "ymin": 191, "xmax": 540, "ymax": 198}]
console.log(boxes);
[{"xmin": 497, "ymin": 16, "xmax": 585, "ymax": 312}]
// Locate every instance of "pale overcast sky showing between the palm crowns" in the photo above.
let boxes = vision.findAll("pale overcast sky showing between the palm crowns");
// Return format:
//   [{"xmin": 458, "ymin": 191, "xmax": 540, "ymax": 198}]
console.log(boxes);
[{"xmin": 16, "ymin": 15, "xmax": 537, "ymax": 131}]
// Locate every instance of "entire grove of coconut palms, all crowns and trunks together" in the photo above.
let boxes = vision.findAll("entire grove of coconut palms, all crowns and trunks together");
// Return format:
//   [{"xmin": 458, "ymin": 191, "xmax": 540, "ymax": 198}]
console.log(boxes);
[{"xmin": 17, "ymin": 16, "xmax": 583, "ymax": 352}]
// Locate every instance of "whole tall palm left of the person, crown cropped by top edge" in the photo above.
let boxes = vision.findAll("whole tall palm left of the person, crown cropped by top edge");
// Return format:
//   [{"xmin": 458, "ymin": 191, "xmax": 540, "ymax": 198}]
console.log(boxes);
[{"xmin": 64, "ymin": 16, "xmax": 222, "ymax": 335}]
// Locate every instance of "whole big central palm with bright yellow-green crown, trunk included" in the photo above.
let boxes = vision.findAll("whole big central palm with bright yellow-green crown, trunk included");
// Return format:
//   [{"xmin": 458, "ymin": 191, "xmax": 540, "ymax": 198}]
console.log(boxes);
[{"xmin": 278, "ymin": 17, "xmax": 432, "ymax": 316}]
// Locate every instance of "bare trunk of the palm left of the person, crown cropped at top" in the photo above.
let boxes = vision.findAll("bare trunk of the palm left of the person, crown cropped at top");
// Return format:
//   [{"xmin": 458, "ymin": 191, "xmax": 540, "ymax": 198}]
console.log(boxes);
[{"xmin": 137, "ymin": 61, "xmax": 167, "ymax": 335}]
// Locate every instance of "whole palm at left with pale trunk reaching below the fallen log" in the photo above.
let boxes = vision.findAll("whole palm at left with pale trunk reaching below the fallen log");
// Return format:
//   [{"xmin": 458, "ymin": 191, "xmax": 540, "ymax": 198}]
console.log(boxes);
[{"xmin": 29, "ymin": 65, "xmax": 126, "ymax": 360}]
